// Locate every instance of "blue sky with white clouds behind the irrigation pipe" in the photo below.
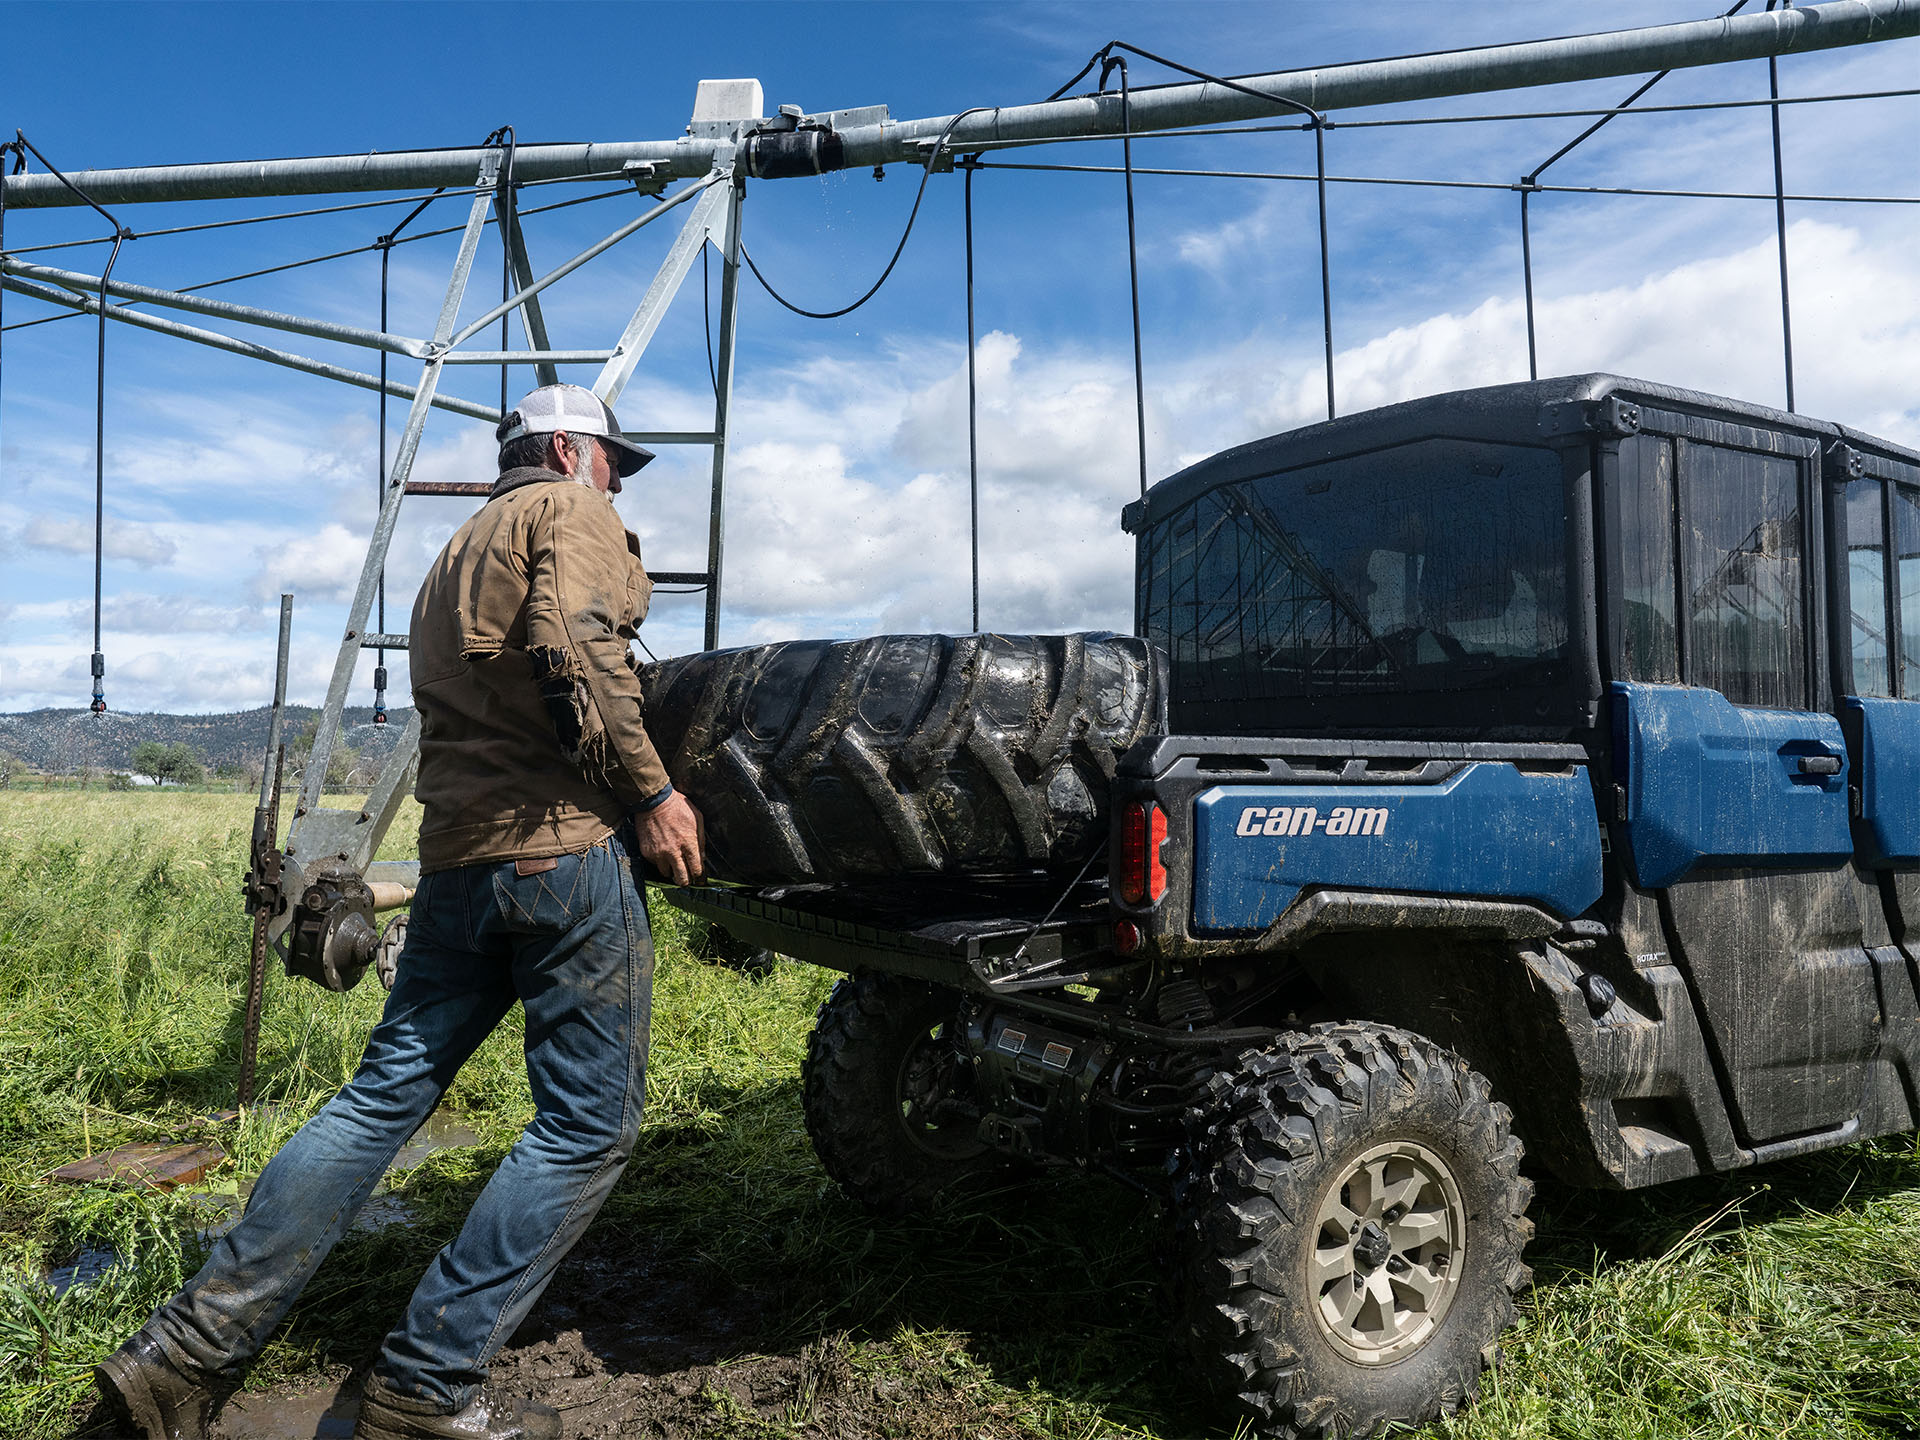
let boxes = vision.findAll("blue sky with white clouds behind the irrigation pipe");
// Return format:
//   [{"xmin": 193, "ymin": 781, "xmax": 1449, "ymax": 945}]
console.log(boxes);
[{"xmin": 0, "ymin": 0, "xmax": 1920, "ymax": 712}]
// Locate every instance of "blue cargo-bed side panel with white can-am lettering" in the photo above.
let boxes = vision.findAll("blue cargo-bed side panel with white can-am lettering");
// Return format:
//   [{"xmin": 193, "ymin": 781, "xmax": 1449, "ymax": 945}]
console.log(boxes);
[{"xmin": 1192, "ymin": 762, "xmax": 1601, "ymax": 933}]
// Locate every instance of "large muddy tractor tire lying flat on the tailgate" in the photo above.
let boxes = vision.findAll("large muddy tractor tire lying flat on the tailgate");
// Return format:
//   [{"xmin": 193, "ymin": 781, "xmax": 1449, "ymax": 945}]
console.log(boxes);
[{"xmin": 641, "ymin": 634, "xmax": 1167, "ymax": 885}]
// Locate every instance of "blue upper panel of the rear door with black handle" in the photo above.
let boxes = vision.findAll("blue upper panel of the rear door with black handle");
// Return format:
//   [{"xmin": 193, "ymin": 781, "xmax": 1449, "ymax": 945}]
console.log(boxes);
[{"xmin": 1613, "ymin": 684, "xmax": 1853, "ymax": 889}]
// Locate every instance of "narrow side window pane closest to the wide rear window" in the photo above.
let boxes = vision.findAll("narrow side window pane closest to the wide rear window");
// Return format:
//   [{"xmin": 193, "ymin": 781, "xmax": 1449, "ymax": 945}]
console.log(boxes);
[{"xmin": 1611, "ymin": 436, "xmax": 1680, "ymax": 684}]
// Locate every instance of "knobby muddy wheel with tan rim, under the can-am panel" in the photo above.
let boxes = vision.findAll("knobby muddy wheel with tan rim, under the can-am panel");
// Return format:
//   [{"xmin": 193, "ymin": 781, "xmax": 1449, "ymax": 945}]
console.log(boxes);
[{"xmin": 1175, "ymin": 1025, "xmax": 1532, "ymax": 1440}]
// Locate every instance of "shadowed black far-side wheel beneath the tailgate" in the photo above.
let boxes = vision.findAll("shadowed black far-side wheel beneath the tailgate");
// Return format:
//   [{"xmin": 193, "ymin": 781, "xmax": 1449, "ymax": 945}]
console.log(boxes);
[{"xmin": 801, "ymin": 973, "xmax": 1002, "ymax": 1213}]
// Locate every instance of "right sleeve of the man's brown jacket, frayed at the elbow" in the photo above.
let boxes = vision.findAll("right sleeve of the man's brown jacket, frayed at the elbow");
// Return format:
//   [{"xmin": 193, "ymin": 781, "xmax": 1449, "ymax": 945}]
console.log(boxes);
[{"xmin": 526, "ymin": 484, "xmax": 666, "ymax": 808}]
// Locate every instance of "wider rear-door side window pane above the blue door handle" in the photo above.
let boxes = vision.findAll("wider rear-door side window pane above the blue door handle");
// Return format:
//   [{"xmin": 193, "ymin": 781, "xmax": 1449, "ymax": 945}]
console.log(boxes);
[{"xmin": 1682, "ymin": 445, "xmax": 1804, "ymax": 710}]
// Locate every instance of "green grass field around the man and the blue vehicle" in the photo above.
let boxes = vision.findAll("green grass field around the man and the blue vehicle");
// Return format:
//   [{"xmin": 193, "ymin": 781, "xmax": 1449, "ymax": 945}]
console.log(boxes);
[{"xmin": 0, "ymin": 791, "xmax": 1920, "ymax": 1440}]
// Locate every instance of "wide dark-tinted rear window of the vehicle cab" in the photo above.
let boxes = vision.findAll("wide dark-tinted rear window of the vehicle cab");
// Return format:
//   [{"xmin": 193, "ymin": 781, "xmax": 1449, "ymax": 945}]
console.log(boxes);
[{"xmin": 1140, "ymin": 440, "xmax": 1567, "ymax": 699}]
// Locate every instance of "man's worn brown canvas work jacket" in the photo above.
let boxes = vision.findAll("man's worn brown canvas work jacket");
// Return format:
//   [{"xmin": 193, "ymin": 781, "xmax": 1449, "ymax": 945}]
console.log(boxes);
[{"xmin": 409, "ymin": 467, "xmax": 666, "ymax": 872}]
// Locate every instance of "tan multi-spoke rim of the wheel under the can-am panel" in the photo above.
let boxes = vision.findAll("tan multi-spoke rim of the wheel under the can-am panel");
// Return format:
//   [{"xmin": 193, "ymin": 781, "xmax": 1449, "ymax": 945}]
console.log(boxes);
[{"xmin": 1308, "ymin": 1140, "xmax": 1467, "ymax": 1365}]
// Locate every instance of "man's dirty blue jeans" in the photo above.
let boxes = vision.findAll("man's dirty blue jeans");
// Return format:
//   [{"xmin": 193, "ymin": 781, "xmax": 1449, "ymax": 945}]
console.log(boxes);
[{"xmin": 148, "ymin": 833, "xmax": 653, "ymax": 1411}]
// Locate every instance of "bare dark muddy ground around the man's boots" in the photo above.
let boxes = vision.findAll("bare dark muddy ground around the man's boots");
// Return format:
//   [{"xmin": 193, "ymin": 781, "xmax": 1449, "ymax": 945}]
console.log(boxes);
[{"xmin": 73, "ymin": 1236, "xmax": 1082, "ymax": 1440}]
